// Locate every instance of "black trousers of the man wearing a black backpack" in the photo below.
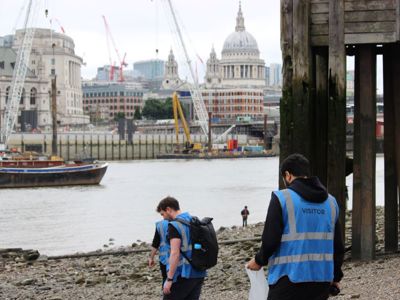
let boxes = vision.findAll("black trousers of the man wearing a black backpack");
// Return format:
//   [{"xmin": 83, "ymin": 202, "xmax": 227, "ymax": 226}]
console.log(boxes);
[{"xmin": 163, "ymin": 277, "xmax": 204, "ymax": 300}]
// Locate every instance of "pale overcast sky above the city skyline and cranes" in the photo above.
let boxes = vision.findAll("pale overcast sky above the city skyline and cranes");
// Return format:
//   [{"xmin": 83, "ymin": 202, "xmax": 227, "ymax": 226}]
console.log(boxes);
[{"xmin": 0, "ymin": 0, "xmax": 281, "ymax": 79}]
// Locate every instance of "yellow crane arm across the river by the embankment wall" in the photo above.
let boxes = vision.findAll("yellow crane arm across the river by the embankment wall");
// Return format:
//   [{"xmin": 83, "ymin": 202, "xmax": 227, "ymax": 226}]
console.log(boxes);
[{"xmin": 172, "ymin": 92, "xmax": 203, "ymax": 153}]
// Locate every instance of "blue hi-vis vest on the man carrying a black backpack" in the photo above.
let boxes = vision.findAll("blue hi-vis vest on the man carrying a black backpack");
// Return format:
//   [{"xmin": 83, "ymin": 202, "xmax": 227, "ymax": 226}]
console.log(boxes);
[{"xmin": 167, "ymin": 212, "xmax": 207, "ymax": 282}]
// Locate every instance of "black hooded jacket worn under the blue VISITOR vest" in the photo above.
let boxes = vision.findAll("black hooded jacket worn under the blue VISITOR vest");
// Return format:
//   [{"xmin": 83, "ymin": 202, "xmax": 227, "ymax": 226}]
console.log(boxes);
[{"xmin": 255, "ymin": 177, "xmax": 344, "ymax": 282}]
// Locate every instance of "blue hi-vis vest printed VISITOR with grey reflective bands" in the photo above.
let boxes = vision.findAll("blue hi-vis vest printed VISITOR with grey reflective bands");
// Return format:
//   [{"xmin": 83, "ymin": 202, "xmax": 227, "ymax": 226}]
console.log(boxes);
[{"xmin": 268, "ymin": 189, "xmax": 339, "ymax": 285}]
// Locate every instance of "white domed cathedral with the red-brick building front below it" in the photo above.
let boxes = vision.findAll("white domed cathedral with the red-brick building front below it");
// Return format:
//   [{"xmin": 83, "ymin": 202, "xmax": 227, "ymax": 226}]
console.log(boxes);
[{"xmin": 202, "ymin": 4, "xmax": 266, "ymax": 119}]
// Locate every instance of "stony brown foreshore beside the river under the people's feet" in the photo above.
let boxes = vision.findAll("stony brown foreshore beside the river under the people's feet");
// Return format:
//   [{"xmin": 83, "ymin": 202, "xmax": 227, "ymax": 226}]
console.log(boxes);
[{"xmin": 0, "ymin": 208, "xmax": 400, "ymax": 300}]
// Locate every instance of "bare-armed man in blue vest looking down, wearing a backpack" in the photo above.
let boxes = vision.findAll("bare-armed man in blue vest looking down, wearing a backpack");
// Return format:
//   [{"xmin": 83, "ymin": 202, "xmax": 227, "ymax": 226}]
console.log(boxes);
[{"xmin": 157, "ymin": 197, "xmax": 206, "ymax": 300}]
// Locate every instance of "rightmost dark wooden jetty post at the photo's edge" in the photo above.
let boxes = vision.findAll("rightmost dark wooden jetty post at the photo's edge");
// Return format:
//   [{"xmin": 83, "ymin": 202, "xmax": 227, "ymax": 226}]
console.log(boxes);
[{"xmin": 383, "ymin": 45, "xmax": 399, "ymax": 251}]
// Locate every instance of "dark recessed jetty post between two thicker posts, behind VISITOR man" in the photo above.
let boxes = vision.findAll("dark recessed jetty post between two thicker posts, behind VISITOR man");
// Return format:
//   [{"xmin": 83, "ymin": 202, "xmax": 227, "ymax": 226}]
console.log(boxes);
[{"xmin": 310, "ymin": 47, "xmax": 328, "ymax": 186}]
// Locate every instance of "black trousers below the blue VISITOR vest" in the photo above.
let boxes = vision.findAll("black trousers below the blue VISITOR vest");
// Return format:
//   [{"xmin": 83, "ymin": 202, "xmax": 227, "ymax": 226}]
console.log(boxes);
[{"xmin": 268, "ymin": 276, "xmax": 330, "ymax": 300}]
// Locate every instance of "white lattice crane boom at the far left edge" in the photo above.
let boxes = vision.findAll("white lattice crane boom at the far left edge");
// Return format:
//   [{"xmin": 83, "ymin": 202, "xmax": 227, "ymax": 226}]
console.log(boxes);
[{"xmin": 0, "ymin": 0, "xmax": 39, "ymax": 150}]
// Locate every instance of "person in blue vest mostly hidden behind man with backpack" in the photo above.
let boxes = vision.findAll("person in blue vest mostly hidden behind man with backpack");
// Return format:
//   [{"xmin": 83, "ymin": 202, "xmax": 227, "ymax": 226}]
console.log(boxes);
[{"xmin": 149, "ymin": 220, "xmax": 170, "ymax": 287}]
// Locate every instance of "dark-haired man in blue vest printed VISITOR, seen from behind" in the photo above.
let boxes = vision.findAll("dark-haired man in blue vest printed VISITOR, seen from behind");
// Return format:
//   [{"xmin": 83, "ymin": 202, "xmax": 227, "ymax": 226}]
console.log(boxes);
[{"xmin": 247, "ymin": 154, "xmax": 344, "ymax": 300}]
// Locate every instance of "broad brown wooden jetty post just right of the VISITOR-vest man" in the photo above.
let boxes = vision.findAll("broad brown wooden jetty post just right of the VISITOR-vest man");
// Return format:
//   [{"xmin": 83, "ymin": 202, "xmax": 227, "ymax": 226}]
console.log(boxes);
[{"xmin": 352, "ymin": 45, "xmax": 376, "ymax": 260}]
